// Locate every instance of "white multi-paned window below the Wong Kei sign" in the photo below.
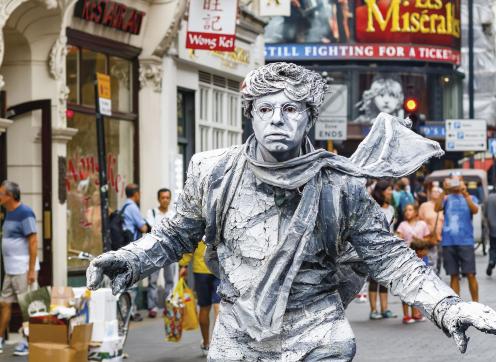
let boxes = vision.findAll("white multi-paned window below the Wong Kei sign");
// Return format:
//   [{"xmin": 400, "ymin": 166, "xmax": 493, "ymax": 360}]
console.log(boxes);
[{"xmin": 197, "ymin": 72, "xmax": 242, "ymax": 151}]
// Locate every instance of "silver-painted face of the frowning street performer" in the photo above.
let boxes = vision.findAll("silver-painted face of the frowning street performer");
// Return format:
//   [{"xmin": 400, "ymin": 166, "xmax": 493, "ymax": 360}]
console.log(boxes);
[{"xmin": 252, "ymin": 91, "xmax": 310, "ymax": 161}]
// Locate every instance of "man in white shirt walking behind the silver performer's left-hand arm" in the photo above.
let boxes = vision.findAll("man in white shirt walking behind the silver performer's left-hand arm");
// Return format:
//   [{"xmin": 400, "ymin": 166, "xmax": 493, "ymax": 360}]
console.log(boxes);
[{"xmin": 146, "ymin": 188, "xmax": 179, "ymax": 318}]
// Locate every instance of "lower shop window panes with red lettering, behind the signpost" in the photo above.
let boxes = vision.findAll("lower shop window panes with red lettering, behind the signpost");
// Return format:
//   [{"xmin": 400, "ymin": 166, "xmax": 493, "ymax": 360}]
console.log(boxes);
[{"xmin": 65, "ymin": 112, "xmax": 134, "ymax": 269}]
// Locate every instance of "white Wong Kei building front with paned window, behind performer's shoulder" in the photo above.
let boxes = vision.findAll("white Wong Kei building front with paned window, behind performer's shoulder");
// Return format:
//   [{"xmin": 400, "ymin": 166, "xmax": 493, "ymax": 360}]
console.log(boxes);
[{"xmin": 163, "ymin": 7, "xmax": 265, "ymax": 196}]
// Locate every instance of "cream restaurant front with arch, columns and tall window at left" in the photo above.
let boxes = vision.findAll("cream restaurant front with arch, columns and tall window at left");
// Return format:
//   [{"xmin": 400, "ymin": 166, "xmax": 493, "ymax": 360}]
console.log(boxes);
[{"xmin": 0, "ymin": 0, "xmax": 184, "ymax": 285}]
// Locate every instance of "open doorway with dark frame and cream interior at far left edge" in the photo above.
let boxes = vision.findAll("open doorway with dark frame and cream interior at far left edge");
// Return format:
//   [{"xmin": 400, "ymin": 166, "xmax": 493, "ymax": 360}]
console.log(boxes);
[{"xmin": 0, "ymin": 97, "xmax": 52, "ymax": 285}]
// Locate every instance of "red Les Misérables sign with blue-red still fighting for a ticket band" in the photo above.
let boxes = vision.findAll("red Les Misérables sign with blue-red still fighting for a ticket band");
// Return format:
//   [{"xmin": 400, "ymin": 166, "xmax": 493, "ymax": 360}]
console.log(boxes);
[{"xmin": 265, "ymin": 0, "xmax": 461, "ymax": 64}]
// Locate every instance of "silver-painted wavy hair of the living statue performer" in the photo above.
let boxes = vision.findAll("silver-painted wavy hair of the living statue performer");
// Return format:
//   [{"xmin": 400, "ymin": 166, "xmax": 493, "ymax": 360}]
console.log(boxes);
[{"xmin": 241, "ymin": 62, "xmax": 327, "ymax": 125}]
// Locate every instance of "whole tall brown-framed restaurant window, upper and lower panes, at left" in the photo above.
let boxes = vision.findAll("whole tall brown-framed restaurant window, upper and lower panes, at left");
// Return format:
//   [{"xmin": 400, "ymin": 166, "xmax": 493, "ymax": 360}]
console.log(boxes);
[{"xmin": 65, "ymin": 41, "xmax": 137, "ymax": 271}]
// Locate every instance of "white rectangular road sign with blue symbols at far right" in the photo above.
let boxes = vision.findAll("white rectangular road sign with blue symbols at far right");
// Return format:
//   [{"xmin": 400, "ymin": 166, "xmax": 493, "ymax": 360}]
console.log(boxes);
[{"xmin": 446, "ymin": 119, "xmax": 487, "ymax": 151}]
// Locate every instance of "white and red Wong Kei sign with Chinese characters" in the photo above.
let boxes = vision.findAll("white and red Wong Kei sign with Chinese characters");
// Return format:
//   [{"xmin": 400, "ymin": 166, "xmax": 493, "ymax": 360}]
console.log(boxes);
[{"xmin": 186, "ymin": 0, "xmax": 237, "ymax": 51}]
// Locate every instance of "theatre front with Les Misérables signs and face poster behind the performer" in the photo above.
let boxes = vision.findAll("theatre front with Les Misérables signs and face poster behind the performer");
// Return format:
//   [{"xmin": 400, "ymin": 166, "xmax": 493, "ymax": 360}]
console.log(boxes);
[{"xmin": 265, "ymin": 0, "xmax": 463, "ymax": 170}]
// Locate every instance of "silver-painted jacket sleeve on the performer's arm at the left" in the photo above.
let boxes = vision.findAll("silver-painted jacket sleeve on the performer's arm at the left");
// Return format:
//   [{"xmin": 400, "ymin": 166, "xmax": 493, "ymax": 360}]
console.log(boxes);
[{"xmin": 117, "ymin": 156, "xmax": 208, "ymax": 283}]
